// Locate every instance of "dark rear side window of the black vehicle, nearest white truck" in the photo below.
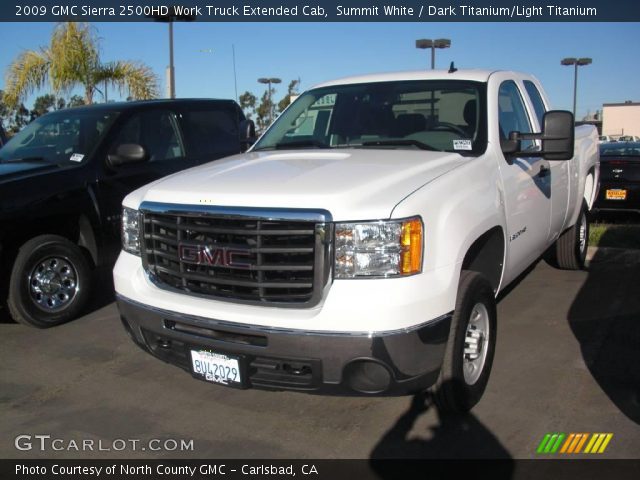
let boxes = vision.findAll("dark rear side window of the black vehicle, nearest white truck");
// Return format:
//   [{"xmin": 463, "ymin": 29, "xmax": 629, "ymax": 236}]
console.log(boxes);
[{"xmin": 182, "ymin": 106, "xmax": 240, "ymax": 160}]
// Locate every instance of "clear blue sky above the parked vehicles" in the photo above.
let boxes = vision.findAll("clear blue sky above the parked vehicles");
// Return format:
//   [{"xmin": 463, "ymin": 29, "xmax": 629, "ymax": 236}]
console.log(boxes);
[{"xmin": 0, "ymin": 22, "xmax": 640, "ymax": 118}]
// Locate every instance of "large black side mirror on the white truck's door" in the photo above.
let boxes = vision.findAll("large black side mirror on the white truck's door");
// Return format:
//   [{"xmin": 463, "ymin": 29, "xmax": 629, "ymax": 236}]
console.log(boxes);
[{"xmin": 500, "ymin": 110, "xmax": 575, "ymax": 160}]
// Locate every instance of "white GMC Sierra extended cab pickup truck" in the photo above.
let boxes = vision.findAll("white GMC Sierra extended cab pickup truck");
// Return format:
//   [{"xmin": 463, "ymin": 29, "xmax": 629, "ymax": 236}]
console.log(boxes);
[{"xmin": 114, "ymin": 68, "xmax": 599, "ymax": 411}]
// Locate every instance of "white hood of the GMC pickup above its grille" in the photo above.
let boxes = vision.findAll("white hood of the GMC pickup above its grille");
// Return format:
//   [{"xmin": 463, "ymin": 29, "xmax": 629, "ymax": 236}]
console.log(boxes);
[{"xmin": 124, "ymin": 149, "xmax": 469, "ymax": 220}]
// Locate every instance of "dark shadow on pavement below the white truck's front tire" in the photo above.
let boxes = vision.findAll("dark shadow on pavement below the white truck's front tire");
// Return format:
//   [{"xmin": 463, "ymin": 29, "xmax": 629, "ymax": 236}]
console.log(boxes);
[{"xmin": 371, "ymin": 386, "xmax": 514, "ymax": 472}]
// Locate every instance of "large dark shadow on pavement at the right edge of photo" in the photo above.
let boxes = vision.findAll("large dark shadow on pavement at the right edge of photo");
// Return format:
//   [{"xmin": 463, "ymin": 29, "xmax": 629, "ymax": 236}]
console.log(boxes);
[{"xmin": 569, "ymin": 232, "xmax": 640, "ymax": 424}]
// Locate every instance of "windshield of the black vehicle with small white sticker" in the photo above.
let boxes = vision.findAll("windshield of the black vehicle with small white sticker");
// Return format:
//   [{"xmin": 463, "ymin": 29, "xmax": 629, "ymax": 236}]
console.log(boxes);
[{"xmin": 0, "ymin": 109, "xmax": 118, "ymax": 164}]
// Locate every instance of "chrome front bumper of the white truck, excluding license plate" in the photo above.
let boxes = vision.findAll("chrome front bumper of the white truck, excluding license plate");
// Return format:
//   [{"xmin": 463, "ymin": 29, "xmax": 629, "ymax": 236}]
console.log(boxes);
[{"xmin": 117, "ymin": 295, "xmax": 451, "ymax": 395}]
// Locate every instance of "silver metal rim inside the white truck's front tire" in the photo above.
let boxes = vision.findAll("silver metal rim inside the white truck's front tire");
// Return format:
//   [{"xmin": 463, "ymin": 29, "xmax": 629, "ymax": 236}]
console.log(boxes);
[{"xmin": 462, "ymin": 303, "xmax": 489, "ymax": 385}]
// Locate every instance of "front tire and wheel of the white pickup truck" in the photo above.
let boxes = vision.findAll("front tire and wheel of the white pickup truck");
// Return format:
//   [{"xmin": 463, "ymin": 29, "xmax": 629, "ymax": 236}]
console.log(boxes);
[{"xmin": 431, "ymin": 270, "xmax": 497, "ymax": 413}]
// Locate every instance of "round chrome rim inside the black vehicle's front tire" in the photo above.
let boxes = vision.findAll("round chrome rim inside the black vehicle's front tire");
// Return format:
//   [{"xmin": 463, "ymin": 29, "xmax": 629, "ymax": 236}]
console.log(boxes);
[{"xmin": 29, "ymin": 257, "xmax": 80, "ymax": 312}]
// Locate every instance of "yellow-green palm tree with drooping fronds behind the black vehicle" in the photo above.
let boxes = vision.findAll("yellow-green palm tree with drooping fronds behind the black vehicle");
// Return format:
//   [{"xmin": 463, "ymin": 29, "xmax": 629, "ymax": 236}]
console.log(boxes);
[{"xmin": 3, "ymin": 22, "xmax": 158, "ymax": 107}]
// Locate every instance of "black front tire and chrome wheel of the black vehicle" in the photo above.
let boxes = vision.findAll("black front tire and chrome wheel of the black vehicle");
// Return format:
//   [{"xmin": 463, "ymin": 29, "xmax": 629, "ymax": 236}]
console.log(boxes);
[{"xmin": 7, "ymin": 235, "xmax": 91, "ymax": 328}]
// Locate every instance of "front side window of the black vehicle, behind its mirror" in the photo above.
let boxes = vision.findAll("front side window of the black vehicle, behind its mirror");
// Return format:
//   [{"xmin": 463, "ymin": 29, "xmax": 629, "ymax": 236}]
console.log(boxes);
[{"xmin": 110, "ymin": 110, "xmax": 185, "ymax": 162}]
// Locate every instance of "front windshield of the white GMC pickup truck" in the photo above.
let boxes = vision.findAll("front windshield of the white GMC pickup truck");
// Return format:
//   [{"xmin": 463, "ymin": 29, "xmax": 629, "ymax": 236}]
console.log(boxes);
[{"xmin": 253, "ymin": 80, "xmax": 487, "ymax": 154}]
